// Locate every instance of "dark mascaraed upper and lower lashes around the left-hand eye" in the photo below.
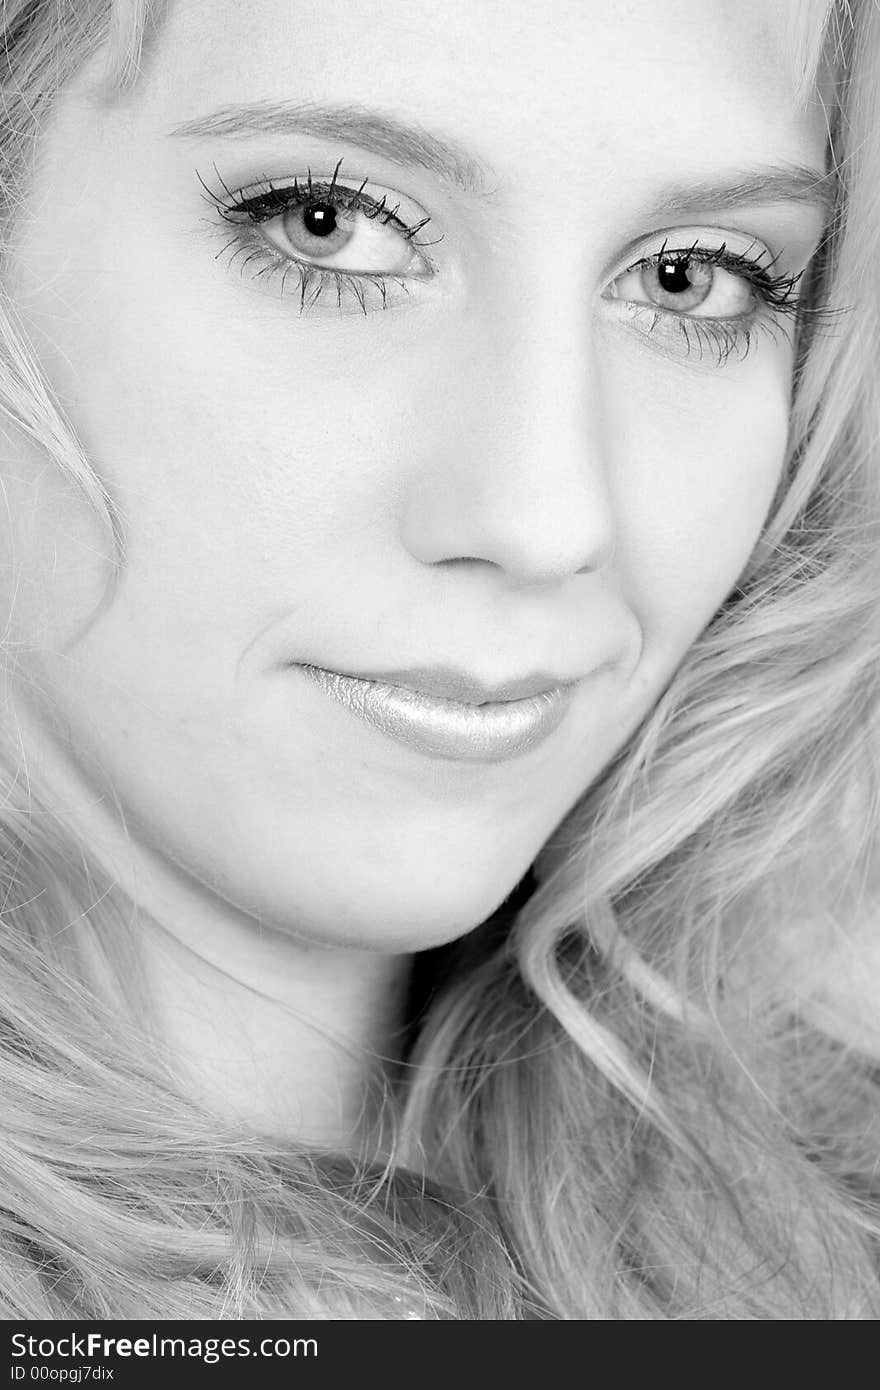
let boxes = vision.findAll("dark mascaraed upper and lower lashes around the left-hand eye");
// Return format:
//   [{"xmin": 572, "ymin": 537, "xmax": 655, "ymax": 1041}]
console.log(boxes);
[{"xmin": 196, "ymin": 160, "xmax": 435, "ymax": 316}]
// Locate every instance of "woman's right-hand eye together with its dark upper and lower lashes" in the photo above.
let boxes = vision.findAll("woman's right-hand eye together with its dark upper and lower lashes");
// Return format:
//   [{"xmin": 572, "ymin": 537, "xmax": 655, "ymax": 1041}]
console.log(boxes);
[{"xmin": 606, "ymin": 238, "xmax": 804, "ymax": 366}]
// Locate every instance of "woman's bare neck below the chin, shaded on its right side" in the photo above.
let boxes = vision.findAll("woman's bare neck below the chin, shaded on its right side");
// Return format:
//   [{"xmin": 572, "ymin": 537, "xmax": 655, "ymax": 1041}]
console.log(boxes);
[{"xmin": 142, "ymin": 913, "xmax": 409, "ymax": 1154}]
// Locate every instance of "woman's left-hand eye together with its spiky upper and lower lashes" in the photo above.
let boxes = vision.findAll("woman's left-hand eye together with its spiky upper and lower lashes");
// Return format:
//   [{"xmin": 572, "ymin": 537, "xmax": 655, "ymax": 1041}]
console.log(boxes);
[{"xmin": 199, "ymin": 161, "xmax": 434, "ymax": 314}]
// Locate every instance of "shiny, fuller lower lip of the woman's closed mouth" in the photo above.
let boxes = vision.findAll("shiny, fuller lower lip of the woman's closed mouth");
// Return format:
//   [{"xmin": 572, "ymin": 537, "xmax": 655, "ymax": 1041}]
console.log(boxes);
[{"xmin": 300, "ymin": 666, "xmax": 573, "ymax": 763}]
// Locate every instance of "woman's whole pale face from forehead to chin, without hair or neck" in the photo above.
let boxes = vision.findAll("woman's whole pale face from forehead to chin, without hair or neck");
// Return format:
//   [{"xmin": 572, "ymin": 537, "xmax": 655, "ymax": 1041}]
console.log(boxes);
[{"xmin": 4, "ymin": 0, "xmax": 823, "ymax": 949}]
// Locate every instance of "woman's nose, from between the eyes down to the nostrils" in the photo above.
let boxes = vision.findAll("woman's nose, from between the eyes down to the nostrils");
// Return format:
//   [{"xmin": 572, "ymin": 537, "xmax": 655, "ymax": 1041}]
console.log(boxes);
[{"xmin": 402, "ymin": 309, "xmax": 614, "ymax": 587}]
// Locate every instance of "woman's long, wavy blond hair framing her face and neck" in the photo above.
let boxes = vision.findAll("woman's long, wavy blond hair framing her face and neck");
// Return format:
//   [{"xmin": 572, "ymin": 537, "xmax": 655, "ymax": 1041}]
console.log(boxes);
[{"xmin": 0, "ymin": 0, "xmax": 880, "ymax": 1319}]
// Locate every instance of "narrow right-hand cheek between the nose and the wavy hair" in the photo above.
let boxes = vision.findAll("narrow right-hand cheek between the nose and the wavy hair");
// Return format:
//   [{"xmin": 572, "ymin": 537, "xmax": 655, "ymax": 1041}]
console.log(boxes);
[{"xmin": 603, "ymin": 343, "xmax": 791, "ymax": 674}]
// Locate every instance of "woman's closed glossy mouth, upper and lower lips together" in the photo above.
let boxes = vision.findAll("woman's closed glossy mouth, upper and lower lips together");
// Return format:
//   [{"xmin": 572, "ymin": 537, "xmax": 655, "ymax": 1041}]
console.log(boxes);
[{"xmin": 299, "ymin": 664, "xmax": 574, "ymax": 762}]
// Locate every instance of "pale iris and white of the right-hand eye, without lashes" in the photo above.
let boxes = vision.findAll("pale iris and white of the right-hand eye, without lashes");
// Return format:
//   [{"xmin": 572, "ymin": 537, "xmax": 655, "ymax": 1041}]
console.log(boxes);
[{"xmin": 610, "ymin": 247, "xmax": 755, "ymax": 318}]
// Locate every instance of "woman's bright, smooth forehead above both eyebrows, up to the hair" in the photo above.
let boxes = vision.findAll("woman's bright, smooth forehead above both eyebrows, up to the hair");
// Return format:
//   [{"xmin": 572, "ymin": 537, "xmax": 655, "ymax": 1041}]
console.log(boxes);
[{"xmin": 139, "ymin": 0, "xmax": 824, "ymax": 179}]
